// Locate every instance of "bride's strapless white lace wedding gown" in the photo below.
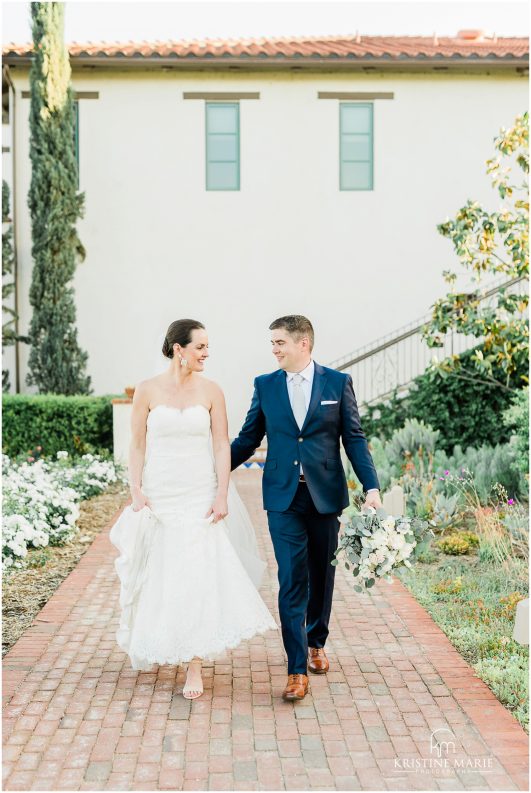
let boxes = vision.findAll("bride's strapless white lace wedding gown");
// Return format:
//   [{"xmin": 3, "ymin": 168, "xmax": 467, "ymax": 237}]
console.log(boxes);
[{"xmin": 110, "ymin": 405, "xmax": 278, "ymax": 670}]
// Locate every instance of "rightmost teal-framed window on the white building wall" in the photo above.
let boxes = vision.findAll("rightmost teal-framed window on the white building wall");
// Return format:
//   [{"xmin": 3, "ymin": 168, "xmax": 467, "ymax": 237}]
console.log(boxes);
[{"xmin": 339, "ymin": 102, "xmax": 373, "ymax": 190}]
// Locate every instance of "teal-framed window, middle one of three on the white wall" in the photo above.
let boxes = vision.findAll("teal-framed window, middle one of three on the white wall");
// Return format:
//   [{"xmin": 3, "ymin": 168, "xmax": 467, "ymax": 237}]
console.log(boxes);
[{"xmin": 206, "ymin": 102, "xmax": 240, "ymax": 190}]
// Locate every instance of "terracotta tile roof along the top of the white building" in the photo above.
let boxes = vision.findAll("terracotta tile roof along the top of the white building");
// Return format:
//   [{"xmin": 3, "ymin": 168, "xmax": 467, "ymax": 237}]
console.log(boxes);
[{"xmin": 2, "ymin": 31, "xmax": 529, "ymax": 59}]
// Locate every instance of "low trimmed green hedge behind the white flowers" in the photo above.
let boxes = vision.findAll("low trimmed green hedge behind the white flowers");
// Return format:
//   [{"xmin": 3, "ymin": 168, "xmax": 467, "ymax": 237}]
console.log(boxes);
[{"xmin": 2, "ymin": 394, "xmax": 113, "ymax": 457}]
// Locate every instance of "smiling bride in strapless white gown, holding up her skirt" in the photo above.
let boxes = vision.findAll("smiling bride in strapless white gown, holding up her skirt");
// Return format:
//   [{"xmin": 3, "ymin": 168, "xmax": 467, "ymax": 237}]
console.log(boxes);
[{"xmin": 110, "ymin": 319, "xmax": 278, "ymax": 699}]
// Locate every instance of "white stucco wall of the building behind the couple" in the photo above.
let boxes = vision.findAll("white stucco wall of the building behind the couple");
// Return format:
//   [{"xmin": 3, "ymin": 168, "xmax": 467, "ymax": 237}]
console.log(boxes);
[{"xmin": 7, "ymin": 69, "xmax": 527, "ymax": 434}]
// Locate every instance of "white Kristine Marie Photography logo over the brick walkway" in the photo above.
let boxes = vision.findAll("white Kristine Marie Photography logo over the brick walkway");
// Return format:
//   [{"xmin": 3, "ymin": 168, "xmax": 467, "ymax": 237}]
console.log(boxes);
[{"xmin": 395, "ymin": 727, "xmax": 494, "ymax": 776}]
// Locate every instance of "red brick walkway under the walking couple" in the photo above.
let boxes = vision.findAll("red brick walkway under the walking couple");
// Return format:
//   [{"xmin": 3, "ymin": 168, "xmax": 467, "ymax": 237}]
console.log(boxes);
[{"xmin": 3, "ymin": 471, "xmax": 528, "ymax": 790}]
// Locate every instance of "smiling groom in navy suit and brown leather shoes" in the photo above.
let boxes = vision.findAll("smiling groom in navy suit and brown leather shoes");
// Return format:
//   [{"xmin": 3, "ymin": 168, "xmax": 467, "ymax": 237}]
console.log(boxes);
[{"xmin": 231, "ymin": 315, "xmax": 381, "ymax": 701}]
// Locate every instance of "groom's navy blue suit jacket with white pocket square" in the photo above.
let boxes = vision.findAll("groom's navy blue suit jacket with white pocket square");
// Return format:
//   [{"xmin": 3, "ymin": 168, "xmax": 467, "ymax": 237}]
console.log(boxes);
[{"xmin": 231, "ymin": 363, "xmax": 380, "ymax": 514}]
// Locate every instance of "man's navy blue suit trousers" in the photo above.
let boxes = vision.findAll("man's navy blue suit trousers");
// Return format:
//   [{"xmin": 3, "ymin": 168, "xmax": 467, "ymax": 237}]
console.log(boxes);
[{"xmin": 267, "ymin": 482, "xmax": 341, "ymax": 675}]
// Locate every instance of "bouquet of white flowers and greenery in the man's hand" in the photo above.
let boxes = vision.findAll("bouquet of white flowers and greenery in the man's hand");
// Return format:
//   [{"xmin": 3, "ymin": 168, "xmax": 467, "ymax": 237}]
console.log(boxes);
[{"xmin": 331, "ymin": 507, "xmax": 435, "ymax": 592}]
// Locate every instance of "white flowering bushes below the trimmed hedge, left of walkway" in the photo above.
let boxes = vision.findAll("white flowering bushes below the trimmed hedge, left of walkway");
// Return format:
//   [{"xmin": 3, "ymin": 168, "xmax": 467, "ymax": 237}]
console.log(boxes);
[{"xmin": 2, "ymin": 452, "xmax": 124, "ymax": 571}]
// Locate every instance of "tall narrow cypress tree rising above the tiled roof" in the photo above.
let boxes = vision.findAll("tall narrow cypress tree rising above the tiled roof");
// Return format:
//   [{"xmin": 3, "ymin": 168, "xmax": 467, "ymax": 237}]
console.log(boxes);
[{"xmin": 26, "ymin": 2, "xmax": 90, "ymax": 394}]
